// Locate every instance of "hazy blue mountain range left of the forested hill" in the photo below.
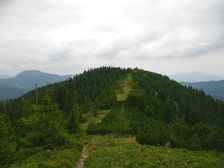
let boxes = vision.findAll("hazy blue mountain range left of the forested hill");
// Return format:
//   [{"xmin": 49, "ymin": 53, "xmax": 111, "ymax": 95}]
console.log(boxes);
[{"xmin": 0, "ymin": 70, "xmax": 71, "ymax": 100}]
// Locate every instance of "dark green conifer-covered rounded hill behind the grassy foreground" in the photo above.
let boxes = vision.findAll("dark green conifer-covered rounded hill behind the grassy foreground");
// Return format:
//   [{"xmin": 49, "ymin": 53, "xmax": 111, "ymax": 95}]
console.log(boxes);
[{"xmin": 0, "ymin": 67, "xmax": 224, "ymax": 167}]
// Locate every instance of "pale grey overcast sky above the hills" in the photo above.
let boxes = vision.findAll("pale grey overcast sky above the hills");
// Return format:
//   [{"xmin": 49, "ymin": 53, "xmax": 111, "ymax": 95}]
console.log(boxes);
[{"xmin": 0, "ymin": 0, "xmax": 224, "ymax": 76}]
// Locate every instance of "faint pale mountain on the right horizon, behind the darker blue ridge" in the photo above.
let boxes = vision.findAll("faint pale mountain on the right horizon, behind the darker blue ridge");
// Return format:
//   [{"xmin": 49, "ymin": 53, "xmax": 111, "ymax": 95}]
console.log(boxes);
[{"xmin": 170, "ymin": 71, "xmax": 221, "ymax": 82}]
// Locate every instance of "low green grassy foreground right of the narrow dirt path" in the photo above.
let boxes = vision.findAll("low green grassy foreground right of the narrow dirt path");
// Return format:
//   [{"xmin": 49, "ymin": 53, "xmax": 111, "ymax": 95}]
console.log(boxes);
[{"xmin": 85, "ymin": 135, "xmax": 224, "ymax": 168}]
